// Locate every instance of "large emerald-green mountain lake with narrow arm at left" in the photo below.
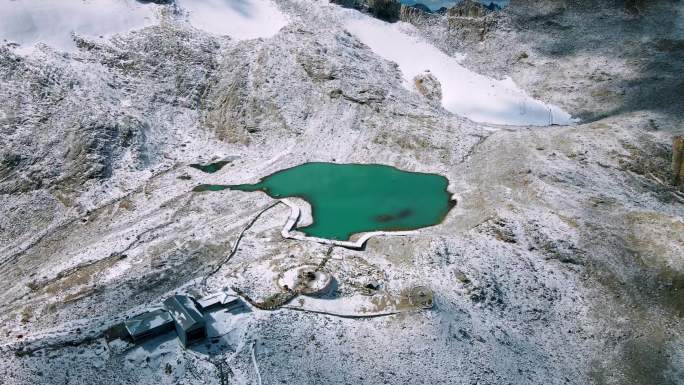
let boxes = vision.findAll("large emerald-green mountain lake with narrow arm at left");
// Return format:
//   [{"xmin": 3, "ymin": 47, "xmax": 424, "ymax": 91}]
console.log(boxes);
[{"xmin": 194, "ymin": 162, "xmax": 453, "ymax": 240}]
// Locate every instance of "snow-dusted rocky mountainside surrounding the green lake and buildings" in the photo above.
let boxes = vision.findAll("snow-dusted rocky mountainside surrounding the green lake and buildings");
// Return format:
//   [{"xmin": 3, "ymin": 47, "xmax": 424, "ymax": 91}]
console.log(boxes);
[{"xmin": 0, "ymin": 0, "xmax": 684, "ymax": 385}]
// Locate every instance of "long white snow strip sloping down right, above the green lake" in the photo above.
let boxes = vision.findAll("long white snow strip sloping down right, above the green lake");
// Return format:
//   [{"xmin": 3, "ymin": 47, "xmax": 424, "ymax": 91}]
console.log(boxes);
[{"xmin": 344, "ymin": 12, "xmax": 576, "ymax": 126}]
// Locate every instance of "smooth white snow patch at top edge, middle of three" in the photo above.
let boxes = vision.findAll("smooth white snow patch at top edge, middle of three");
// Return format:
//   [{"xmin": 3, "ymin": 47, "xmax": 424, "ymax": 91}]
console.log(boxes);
[{"xmin": 178, "ymin": 0, "xmax": 287, "ymax": 40}]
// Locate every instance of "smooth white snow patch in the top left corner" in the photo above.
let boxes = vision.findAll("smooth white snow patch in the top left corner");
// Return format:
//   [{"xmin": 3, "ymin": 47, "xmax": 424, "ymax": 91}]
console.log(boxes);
[{"xmin": 0, "ymin": 0, "xmax": 159, "ymax": 53}]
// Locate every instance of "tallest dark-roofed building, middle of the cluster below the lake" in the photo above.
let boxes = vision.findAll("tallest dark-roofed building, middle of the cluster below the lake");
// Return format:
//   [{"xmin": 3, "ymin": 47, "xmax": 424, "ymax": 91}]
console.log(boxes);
[{"xmin": 164, "ymin": 295, "xmax": 207, "ymax": 347}]
